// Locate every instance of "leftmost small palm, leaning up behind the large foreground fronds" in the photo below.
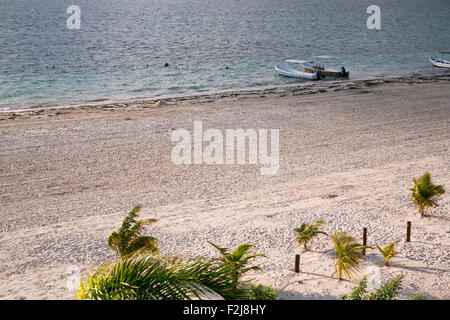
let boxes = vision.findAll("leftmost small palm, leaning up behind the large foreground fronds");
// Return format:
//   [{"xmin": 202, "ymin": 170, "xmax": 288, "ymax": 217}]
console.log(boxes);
[{"xmin": 108, "ymin": 206, "xmax": 158, "ymax": 258}]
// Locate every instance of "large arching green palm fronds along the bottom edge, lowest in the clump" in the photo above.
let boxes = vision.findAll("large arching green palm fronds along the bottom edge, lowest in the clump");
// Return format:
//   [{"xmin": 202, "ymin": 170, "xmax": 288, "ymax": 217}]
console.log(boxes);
[{"xmin": 76, "ymin": 252, "xmax": 249, "ymax": 300}]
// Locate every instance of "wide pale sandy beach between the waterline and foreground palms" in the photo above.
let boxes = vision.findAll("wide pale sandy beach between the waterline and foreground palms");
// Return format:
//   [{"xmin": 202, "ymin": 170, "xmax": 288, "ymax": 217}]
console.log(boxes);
[{"xmin": 0, "ymin": 75, "xmax": 450, "ymax": 299}]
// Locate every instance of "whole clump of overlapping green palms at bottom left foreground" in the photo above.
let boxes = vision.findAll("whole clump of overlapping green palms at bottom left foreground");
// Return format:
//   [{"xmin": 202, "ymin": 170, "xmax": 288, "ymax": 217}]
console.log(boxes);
[{"xmin": 76, "ymin": 206, "xmax": 272, "ymax": 300}]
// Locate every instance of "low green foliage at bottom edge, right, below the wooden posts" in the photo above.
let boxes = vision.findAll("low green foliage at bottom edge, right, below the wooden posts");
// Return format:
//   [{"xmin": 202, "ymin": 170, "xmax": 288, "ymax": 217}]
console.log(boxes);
[{"xmin": 340, "ymin": 275, "xmax": 405, "ymax": 300}]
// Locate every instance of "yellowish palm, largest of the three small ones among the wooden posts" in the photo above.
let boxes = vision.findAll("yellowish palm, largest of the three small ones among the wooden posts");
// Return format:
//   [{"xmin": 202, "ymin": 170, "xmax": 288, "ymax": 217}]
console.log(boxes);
[{"xmin": 331, "ymin": 231, "xmax": 371, "ymax": 280}]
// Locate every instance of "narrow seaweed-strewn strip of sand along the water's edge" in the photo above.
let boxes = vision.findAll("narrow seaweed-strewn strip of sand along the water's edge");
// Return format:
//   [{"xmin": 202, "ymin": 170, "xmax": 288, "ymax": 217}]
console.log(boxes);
[{"xmin": 0, "ymin": 73, "xmax": 450, "ymax": 119}]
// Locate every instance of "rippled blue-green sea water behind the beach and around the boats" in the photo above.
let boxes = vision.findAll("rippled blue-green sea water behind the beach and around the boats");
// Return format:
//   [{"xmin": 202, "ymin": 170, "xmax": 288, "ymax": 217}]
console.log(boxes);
[{"xmin": 0, "ymin": 0, "xmax": 450, "ymax": 110}]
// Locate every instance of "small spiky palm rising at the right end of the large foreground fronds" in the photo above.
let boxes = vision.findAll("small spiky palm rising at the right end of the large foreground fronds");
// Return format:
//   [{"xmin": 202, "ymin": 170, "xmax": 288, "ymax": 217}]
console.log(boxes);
[{"xmin": 208, "ymin": 241, "xmax": 266, "ymax": 288}]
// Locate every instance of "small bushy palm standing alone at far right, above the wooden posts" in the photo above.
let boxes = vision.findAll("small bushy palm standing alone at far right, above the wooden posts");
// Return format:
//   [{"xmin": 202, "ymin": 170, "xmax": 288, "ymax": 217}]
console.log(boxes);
[{"xmin": 409, "ymin": 172, "xmax": 445, "ymax": 215}]
